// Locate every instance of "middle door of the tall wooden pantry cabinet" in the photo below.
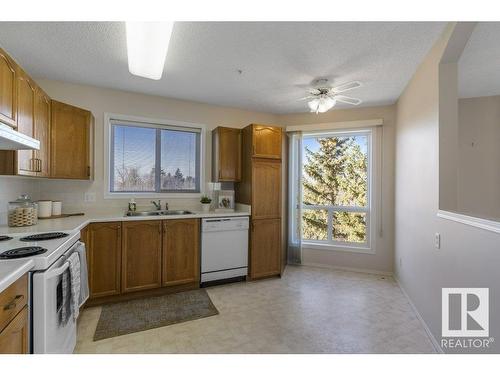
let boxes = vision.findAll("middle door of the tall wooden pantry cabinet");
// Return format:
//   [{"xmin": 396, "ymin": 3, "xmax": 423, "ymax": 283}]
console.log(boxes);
[{"xmin": 251, "ymin": 159, "xmax": 281, "ymax": 219}]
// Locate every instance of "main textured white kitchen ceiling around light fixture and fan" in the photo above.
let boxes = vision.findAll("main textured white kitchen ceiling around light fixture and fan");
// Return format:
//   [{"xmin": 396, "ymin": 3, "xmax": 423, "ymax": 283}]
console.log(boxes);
[{"xmin": 0, "ymin": 22, "xmax": 445, "ymax": 113}]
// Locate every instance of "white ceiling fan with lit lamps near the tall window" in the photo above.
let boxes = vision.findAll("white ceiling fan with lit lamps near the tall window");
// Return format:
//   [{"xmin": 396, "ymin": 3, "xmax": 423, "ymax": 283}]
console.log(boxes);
[{"xmin": 299, "ymin": 78, "xmax": 362, "ymax": 113}]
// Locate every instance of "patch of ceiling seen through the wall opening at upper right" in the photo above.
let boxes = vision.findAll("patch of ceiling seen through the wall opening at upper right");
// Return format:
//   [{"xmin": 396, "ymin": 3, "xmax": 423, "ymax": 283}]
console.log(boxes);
[{"xmin": 458, "ymin": 22, "xmax": 500, "ymax": 98}]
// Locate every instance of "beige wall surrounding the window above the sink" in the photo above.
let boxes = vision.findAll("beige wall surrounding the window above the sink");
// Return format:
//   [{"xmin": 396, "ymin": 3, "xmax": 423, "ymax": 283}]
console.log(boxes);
[{"xmin": 37, "ymin": 80, "xmax": 277, "ymax": 214}]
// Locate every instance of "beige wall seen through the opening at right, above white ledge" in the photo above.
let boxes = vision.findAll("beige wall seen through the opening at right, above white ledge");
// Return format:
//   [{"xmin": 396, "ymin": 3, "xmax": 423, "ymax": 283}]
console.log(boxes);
[{"xmin": 458, "ymin": 96, "xmax": 500, "ymax": 220}]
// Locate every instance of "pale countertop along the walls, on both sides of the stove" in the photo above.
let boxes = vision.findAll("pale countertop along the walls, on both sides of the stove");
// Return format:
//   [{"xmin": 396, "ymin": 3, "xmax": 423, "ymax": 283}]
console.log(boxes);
[{"xmin": 0, "ymin": 205, "xmax": 250, "ymax": 293}]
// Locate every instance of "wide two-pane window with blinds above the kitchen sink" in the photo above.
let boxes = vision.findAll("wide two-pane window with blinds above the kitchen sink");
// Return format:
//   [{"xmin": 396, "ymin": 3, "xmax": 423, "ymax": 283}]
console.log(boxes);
[{"xmin": 109, "ymin": 120, "xmax": 201, "ymax": 193}]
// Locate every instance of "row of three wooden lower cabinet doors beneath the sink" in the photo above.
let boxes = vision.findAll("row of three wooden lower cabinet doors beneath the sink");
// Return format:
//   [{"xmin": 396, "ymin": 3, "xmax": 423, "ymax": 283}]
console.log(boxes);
[{"xmin": 80, "ymin": 219, "xmax": 200, "ymax": 305}]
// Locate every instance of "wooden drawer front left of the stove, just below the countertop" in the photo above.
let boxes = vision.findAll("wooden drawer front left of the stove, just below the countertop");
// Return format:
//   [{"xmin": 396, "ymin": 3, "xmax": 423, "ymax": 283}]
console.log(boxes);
[{"xmin": 0, "ymin": 274, "xmax": 28, "ymax": 332}]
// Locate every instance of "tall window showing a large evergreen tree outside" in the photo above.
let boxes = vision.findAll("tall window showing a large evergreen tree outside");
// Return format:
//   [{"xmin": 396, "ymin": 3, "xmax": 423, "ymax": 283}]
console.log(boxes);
[{"xmin": 292, "ymin": 131, "xmax": 371, "ymax": 247}]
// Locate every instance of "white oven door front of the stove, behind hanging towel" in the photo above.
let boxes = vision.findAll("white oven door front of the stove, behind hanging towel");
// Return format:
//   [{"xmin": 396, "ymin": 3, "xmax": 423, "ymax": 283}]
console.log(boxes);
[{"xmin": 32, "ymin": 242, "xmax": 79, "ymax": 354}]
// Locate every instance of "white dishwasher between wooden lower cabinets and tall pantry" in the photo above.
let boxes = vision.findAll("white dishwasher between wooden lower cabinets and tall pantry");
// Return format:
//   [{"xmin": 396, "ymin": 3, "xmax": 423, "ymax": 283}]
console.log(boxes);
[{"xmin": 201, "ymin": 217, "xmax": 248, "ymax": 283}]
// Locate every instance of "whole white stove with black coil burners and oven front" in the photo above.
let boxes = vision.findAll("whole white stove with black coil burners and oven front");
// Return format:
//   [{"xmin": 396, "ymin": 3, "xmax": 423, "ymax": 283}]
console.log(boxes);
[{"xmin": 0, "ymin": 231, "xmax": 88, "ymax": 354}]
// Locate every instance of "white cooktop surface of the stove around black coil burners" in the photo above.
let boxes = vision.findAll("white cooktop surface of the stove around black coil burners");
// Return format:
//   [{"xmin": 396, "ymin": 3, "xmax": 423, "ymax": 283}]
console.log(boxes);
[{"xmin": 0, "ymin": 231, "xmax": 80, "ymax": 271}]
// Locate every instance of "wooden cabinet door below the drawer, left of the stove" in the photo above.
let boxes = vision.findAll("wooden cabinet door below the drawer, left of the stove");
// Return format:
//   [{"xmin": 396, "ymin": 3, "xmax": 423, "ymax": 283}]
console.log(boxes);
[{"xmin": 0, "ymin": 306, "xmax": 29, "ymax": 354}]
